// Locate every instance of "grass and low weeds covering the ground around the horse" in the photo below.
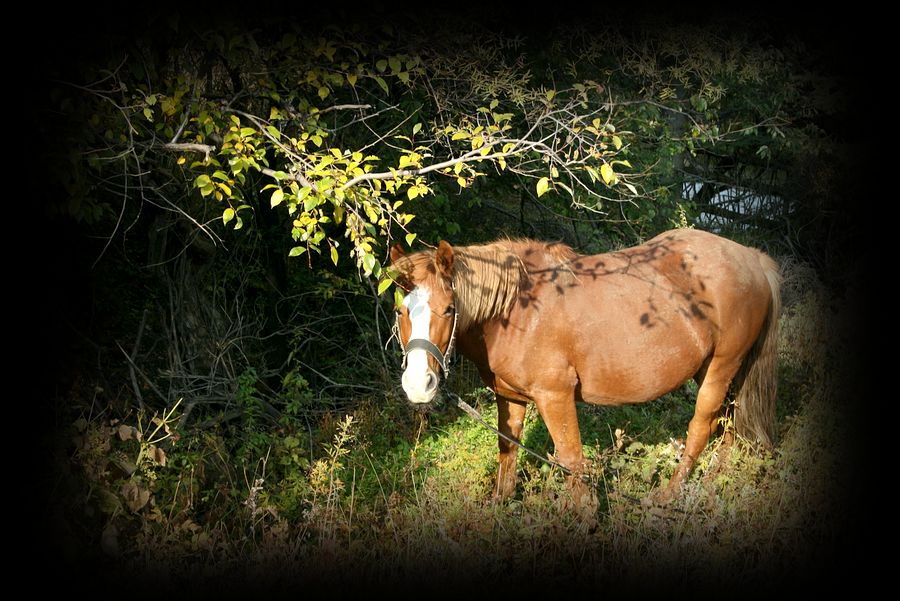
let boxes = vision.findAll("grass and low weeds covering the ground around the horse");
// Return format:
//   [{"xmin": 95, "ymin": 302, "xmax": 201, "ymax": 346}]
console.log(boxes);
[{"xmin": 49, "ymin": 266, "xmax": 852, "ymax": 594}]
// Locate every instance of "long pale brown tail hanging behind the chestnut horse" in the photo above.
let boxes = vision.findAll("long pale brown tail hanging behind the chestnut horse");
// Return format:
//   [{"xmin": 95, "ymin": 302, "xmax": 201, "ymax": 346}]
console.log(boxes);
[{"xmin": 734, "ymin": 252, "xmax": 781, "ymax": 448}]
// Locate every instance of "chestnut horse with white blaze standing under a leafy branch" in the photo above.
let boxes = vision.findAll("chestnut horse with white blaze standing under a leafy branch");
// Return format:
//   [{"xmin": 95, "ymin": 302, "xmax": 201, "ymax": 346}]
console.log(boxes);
[{"xmin": 391, "ymin": 229, "xmax": 780, "ymax": 502}]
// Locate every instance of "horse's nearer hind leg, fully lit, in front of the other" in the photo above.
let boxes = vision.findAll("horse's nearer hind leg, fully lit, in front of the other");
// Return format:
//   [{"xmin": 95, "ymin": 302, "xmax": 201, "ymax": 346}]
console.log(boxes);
[{"xmin": 660, "ymin": 358, "xmax": 740, "ymax": 501}]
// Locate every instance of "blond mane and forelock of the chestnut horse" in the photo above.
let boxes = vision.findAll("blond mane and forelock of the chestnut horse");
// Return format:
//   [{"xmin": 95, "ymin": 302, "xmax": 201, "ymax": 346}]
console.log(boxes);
[{"xmin": 396, "ymin": 239, "xmax": 577, "ymax": 331}]
